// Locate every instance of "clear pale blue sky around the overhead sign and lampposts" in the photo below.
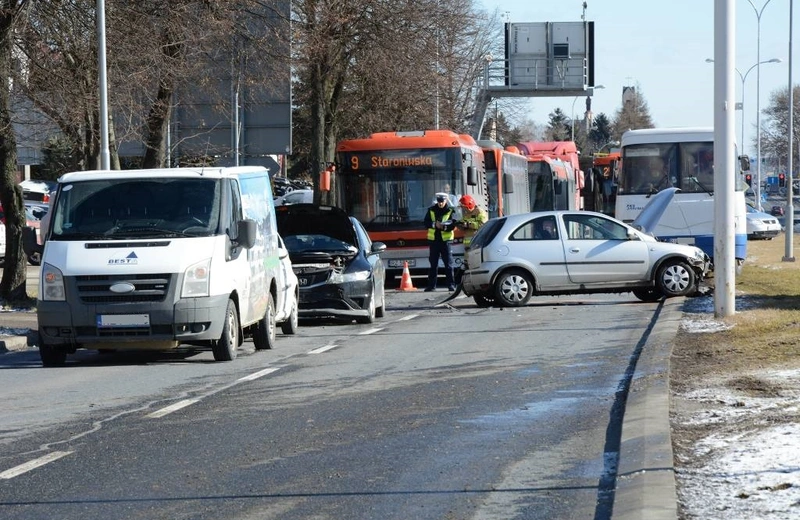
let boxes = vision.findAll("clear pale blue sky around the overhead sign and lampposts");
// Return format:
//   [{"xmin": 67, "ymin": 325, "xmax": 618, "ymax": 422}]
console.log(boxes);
[{"xmin": 478, "ymin": 0, "xmax": 800, "ymax": 154}]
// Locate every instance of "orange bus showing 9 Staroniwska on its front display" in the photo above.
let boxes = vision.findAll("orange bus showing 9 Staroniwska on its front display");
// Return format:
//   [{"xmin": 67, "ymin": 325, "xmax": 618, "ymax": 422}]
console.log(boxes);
[{"xmin": 336, "ymin": 130, "xmax": 489, "ymax": 285}]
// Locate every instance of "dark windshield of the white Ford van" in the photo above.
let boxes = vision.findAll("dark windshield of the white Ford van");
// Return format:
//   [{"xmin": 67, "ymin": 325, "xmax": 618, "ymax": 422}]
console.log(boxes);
[{"xmin": 51, "ymin": 178, "xmax": 221, "ymax": 240}]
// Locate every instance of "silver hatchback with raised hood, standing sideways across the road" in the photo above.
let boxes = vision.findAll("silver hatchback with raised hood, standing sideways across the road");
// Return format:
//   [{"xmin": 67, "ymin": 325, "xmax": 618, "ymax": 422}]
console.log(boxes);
[{"xmin": 462, "ymin": 188, "xmax": 711, "ymax": 307}]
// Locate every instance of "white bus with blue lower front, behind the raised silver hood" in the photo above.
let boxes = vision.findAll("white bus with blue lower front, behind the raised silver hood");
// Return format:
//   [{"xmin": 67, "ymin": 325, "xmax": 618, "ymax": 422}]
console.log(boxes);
[{"xmin": 614, "ymin": 128, "xmax": 747, "ymax": 266}]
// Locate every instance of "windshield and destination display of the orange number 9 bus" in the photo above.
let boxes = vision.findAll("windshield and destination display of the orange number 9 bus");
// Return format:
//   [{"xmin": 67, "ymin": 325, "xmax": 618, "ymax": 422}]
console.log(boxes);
[{"xmin": 339, "ymin": 148, "xmax": 464, "ymax": 231}]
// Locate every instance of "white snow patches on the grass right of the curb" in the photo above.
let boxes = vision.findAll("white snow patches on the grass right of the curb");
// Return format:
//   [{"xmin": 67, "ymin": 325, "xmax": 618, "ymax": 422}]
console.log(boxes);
[{"xmin": 676, "ymin": 298, "xmax": 800, "ymax": 520}]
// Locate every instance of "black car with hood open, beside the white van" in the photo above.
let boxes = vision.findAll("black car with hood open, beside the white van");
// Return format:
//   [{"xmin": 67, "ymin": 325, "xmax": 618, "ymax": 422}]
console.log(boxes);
[{"xmin": 275, "ymin": 204, "xmax": 386, "ymax": 323}]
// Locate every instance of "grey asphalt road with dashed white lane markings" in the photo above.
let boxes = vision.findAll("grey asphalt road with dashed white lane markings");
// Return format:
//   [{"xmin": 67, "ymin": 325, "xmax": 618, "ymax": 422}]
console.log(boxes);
[{"xmin": 0, "ymin": 292, "xmax": 660, "ymax": 520}]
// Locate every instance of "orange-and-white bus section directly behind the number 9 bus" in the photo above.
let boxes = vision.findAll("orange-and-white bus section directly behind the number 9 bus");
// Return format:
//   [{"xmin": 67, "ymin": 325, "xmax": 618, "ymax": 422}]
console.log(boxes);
[{"xmin": 478, "ymin": 141, "xmax": 531, "ymax": 218}]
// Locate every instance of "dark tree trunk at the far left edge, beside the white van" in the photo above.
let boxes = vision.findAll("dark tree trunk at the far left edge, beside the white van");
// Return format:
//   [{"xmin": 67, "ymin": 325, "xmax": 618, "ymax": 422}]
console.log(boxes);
[{"xmin": 0, "ymin": 0, "xmax": 28, "ymax": 301}]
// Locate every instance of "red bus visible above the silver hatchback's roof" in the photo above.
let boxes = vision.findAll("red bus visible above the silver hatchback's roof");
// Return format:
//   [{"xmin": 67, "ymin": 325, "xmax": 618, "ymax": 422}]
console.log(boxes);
[{"xmin": 518, "ymin": 141, "xmax": 583, "ymax": 211}]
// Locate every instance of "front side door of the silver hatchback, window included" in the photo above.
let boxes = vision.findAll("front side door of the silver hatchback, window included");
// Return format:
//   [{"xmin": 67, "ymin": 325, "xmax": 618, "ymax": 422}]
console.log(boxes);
[{"xmin": 563, "ymin": 213, "xmax": 650, "ymax": 285}]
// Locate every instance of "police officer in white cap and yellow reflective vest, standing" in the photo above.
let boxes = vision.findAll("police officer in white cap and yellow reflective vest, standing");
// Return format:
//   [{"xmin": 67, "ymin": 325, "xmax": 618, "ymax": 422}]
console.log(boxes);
[{"xmin": 425, "ymin": 193, "xmax": 456, "ymax": 292}]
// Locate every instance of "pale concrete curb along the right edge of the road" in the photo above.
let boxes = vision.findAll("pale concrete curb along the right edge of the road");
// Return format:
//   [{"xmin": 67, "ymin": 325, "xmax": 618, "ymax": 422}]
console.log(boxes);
[{"xmin": 613, "ymin": 298, "xmax": 685, "ymax": 520}]
